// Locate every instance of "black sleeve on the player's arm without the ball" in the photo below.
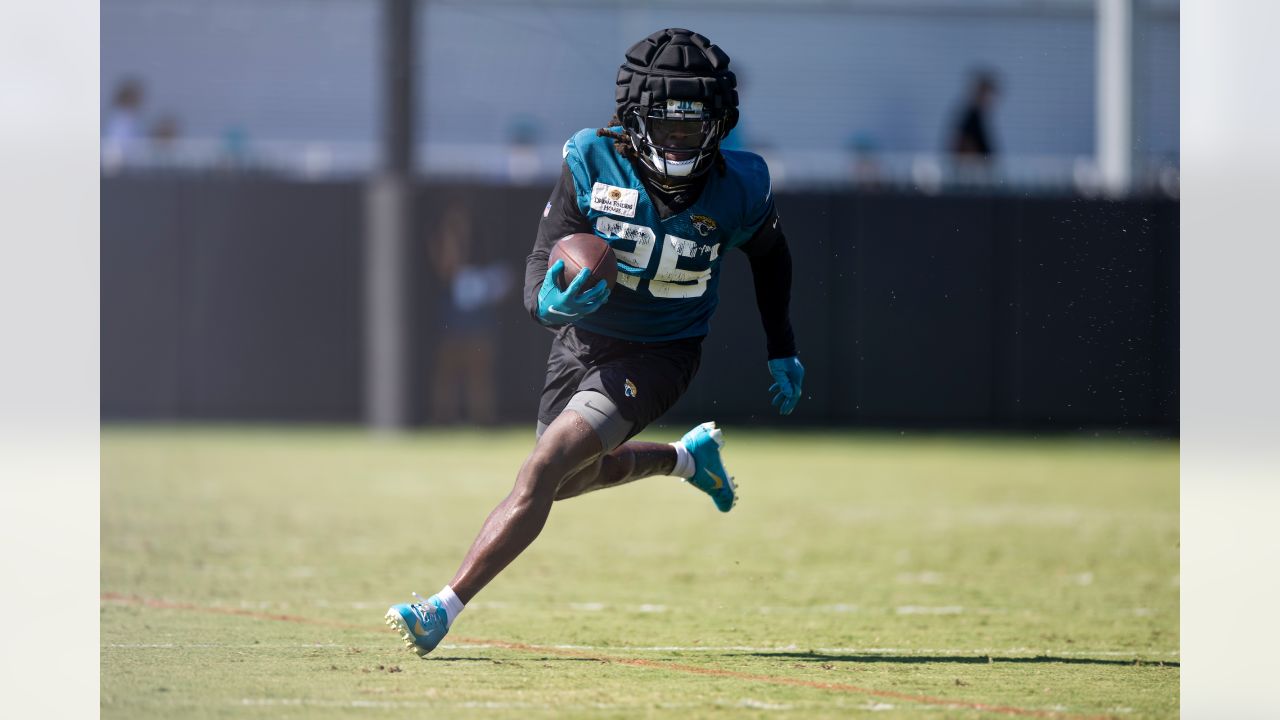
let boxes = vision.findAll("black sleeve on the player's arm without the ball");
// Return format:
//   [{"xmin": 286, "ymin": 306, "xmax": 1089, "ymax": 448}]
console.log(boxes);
[{"xmin": 741, "ymin": 208, "xmax": 796, "ymax": 360}]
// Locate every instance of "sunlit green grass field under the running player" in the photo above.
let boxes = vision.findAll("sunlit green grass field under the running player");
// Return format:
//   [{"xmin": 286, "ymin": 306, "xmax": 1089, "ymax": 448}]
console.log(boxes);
[{"xmin": 101, "ymin": 427, "xmax": 1179, "ymax": 719}]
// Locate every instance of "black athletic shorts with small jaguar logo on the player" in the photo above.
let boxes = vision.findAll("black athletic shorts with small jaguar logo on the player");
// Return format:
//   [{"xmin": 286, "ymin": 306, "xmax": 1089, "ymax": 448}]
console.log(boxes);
[{"xmin": 538, "ymin": 325, "xmax": 703, "ymax": 439}]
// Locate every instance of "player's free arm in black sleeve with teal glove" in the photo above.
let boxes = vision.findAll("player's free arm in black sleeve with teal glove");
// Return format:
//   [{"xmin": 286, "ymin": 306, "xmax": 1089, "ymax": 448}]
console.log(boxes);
[{"xmin": 741, "ymin": 202, "xmax": 804, "ymax": 415}]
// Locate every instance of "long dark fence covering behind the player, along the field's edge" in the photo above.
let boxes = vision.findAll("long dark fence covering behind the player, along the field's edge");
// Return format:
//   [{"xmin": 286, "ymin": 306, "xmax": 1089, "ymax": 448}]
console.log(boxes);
[{"xmin": 101, "ymin": 176, "xmax": 1178, "ymax": 432}]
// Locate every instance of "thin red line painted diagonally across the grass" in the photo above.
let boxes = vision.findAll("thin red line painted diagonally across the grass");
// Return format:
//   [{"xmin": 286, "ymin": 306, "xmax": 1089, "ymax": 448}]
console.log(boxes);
[{"xmin": 102, "ymin": 593, "xmax": 1107, "ymax": 720}]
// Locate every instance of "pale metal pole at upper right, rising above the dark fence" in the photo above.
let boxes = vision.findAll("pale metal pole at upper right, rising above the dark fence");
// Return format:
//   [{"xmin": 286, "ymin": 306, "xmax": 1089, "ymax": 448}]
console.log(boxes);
[{"xmin": 1094, "ymin": 0, "xmax": 1133, "ymax": 195}]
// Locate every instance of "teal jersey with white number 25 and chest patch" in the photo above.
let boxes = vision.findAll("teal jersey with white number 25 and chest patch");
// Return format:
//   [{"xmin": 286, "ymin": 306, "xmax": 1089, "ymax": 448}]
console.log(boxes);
[{"xmin": 564, "ymin": 128, "xmax": 773, "ymax": 342}]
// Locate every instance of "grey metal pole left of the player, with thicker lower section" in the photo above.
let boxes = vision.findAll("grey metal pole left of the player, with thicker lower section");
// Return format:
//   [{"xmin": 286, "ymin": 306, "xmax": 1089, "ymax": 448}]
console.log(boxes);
[{"xmin": 365, "ymin": 0, "xmax": 415, "ymax": 429}]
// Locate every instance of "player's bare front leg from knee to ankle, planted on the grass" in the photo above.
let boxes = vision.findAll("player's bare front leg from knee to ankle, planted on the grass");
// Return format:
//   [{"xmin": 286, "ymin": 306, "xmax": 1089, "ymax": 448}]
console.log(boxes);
[{"xmin": 449, "ymin": 410, "xmax": 604, "ymax": 602}]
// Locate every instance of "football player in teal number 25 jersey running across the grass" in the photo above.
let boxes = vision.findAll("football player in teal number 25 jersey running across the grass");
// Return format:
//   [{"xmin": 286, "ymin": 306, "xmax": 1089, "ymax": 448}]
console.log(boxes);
[{"xmin": 387, "ymin": 28, "xmax": 804, "ymax": 655}]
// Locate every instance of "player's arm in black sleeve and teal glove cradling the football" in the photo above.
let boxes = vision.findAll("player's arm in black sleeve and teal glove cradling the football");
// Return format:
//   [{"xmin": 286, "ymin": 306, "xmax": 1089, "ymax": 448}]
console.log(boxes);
[{"xmin": 525, "ymin": 165, "xmax": 608, "ymax": 325}]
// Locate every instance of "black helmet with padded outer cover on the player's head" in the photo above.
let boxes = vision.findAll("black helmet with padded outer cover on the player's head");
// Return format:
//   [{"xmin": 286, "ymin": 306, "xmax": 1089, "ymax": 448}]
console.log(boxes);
[{"xmin": 617, "ymin": 28, "xmax": 737, "ymax": 188}]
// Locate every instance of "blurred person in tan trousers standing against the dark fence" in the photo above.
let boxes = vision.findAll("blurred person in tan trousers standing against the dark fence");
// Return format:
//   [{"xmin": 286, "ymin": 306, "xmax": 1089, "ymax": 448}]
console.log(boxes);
[{"xmin": 430, "ymin": 205, "xmax": 512, "ymax": 424}]
